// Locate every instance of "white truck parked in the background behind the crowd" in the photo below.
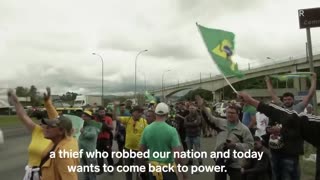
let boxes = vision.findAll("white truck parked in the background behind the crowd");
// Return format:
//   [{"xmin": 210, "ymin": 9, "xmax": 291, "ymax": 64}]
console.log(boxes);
[{"xmin": 73, "ymin": 95, "xmax": 102, "ymax": 107}]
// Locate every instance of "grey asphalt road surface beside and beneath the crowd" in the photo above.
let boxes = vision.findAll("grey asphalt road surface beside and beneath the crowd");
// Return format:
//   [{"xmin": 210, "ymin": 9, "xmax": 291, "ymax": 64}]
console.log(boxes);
[{"xmin": 0, "ymin": 130, "xmax": 218, "ymax": 180}]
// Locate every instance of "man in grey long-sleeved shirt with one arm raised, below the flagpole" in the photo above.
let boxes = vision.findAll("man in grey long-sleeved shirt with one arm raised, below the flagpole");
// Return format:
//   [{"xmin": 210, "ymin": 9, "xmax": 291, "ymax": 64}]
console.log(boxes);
[{"xmin": 196, "ymin": 96, "xmax": 254, "ymax": 180}]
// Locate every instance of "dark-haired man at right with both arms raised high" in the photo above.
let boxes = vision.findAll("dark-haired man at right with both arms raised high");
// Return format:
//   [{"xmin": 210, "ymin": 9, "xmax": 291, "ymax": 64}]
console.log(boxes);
[{"xmin": 266, "ymin": 73, "xmax": 317, "ymax": 180}]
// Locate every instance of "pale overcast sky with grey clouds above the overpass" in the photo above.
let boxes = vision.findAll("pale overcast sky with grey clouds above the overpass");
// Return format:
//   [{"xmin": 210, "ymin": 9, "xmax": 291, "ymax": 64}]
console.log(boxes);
[{"xmin": 0, "ymin": 0, "xmax": 320, "ymax": 97}]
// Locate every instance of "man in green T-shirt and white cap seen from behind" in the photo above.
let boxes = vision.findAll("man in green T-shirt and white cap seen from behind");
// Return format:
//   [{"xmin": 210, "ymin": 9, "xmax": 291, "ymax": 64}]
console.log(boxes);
[{"xmin": 140, "ymin": 103, "xmax": 186, "ymax": 180}]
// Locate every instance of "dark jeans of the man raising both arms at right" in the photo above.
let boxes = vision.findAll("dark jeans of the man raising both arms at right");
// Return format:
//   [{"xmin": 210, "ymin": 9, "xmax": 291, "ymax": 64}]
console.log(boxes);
[{"xmin": 271, "ymin": 152, "xmax": 300, "ymax": 180}]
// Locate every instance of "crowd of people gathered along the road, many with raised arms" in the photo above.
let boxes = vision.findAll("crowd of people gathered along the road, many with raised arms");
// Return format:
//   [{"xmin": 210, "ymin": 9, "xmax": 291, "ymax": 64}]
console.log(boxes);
[{"xmin": 8, "ymin": 73, "xmax": 320, "ymax": 180}]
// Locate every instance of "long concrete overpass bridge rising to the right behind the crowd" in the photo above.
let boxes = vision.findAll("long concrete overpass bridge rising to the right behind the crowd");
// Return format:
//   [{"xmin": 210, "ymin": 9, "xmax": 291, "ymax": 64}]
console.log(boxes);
[{"xmin": 150, "ymin": 54, "xmax": 320, "ymax": 101}]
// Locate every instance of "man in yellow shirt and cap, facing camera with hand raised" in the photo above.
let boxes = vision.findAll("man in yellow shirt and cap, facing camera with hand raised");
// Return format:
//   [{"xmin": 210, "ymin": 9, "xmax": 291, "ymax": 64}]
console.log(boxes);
[{"xmin": 113, "ymin": 102, "xmax": 148, "ymax": 180}]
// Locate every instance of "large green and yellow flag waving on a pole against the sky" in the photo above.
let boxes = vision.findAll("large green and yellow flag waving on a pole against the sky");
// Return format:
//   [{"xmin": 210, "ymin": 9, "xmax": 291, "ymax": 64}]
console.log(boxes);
[{"xmin": 197, "ymin": 24, "xmax": 244, "ymax": 78}]
